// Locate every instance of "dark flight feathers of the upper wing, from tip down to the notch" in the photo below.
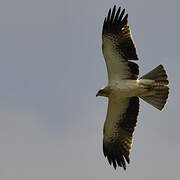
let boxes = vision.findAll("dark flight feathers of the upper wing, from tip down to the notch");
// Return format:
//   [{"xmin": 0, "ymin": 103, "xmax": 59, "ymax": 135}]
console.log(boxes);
[{"xmin": 102, "ymin": 5, "xmax": 138, "ymax": 60}]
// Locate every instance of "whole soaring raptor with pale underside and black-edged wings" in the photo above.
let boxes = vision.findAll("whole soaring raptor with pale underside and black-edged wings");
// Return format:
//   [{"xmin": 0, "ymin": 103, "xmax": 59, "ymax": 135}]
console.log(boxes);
[{"xmin": 96, "ymin": 6, "xmax": 169, "ymax": 170}]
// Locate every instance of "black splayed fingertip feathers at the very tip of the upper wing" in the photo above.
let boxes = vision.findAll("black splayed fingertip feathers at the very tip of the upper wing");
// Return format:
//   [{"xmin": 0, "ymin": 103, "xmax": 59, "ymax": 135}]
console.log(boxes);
[{"xmin": 103, "ymin": 5, "xmax": 128, "ymax": 34}]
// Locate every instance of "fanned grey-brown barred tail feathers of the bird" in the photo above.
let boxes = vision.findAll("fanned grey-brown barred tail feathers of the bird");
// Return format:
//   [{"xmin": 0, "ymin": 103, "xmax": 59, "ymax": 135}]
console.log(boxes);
[{"xmin": 140, "ymin": 65, "xmax": 169, "ymax": 110}]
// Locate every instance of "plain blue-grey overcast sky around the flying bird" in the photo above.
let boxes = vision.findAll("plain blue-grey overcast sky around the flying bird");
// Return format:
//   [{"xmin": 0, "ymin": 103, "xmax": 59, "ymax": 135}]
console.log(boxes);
[{"xmin": 0, "ymin": 0, "xmax": 180, "ymax": 180}]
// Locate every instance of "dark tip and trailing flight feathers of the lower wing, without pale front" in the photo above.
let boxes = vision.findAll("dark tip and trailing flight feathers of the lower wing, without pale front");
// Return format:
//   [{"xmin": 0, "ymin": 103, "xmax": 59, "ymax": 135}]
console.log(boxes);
[{"xmin": 103, "ymin": 97, "xmax": 139, "ymax": 170}]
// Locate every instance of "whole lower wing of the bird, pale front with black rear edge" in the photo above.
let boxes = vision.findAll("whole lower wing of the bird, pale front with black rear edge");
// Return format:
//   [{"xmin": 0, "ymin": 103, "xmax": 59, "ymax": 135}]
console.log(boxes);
[{"xmin": 103, "ymin": 97, "xmax": 139, "ymax": 170}]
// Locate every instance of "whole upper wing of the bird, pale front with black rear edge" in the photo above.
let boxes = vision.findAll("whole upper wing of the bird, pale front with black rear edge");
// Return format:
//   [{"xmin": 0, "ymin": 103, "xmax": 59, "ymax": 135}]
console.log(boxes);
[{"xmin": 102, "ymin": 6, "xmax": 139, "ymax": 83}]
